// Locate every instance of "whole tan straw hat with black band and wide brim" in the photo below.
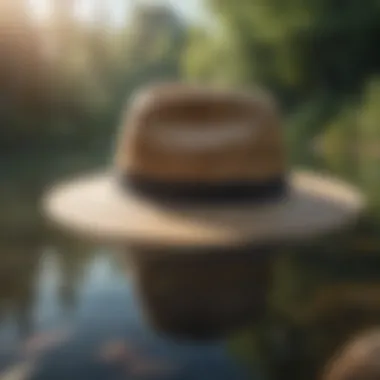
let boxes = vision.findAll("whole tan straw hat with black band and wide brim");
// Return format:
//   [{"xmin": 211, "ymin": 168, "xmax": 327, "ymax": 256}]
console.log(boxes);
[{"xmin": 44, "ymin": 84, "xmax": 364, "ymax": 249}]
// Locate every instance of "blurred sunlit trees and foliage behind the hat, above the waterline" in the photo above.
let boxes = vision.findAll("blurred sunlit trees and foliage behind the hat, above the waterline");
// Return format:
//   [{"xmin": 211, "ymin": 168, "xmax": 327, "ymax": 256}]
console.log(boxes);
[{"xmin": 0, "ymin": 0, "xmax": 380, "ymax": 196}]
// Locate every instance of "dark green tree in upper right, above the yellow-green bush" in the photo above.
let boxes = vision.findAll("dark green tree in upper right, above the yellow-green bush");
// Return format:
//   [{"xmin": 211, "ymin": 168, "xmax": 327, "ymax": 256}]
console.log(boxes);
[{"xmin": 185, "ymin": 0, "xmax": 380, "ymax": 159}]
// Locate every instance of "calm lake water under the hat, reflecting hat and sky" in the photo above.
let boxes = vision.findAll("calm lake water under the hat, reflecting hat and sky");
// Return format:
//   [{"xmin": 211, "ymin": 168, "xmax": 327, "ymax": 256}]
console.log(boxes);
[{"xmin": 0, "ymin": 149, "xmax": 380, "ymax": 380}]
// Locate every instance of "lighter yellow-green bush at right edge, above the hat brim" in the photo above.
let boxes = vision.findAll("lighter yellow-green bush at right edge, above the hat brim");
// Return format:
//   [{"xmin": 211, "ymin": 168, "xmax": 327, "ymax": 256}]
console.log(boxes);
[{"xmin": 314, "ymin": 77, "xmax": 380, "ymax": 209}]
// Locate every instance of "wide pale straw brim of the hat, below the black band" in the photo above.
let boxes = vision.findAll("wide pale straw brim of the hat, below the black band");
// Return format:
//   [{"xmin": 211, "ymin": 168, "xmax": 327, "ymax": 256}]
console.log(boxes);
[{"xmin": 44, "ymin": 171, "xmax": 365, "ymax": 248}]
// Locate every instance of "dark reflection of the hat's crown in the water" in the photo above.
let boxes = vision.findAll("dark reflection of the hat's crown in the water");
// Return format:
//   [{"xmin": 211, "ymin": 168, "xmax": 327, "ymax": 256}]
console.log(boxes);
[{"xmin": 133, "ymin": 250, "xmax": 272, "ymax": 340}]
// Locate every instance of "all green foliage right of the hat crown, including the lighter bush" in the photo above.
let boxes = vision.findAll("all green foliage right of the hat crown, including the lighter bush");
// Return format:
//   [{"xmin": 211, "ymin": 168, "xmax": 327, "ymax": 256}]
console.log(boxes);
[{"xmin": 183, "ymin": 0, "xmax": 380, "ymax": 177}]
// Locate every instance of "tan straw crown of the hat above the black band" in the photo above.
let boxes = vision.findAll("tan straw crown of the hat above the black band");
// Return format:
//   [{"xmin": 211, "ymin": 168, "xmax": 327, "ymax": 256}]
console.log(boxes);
[{"xmin": 116, "ymin": 85, "xmax": 285, "ymax": 184}]
